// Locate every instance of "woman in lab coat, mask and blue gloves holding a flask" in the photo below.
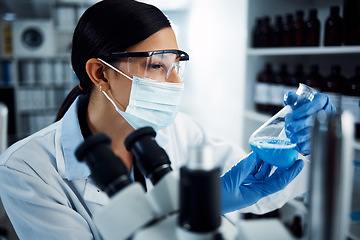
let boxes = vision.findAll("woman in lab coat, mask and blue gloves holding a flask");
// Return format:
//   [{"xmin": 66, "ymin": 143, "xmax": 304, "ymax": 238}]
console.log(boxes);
[{"xmin": 0, "ymin": 0, "xmax": 331, "ymax": 240}]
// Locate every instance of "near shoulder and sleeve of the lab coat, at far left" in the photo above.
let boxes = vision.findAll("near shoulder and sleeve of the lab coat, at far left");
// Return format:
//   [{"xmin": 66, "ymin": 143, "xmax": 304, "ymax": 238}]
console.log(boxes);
[{"xmin": 0, "ymin": 122, "xmax": 94, "ymax": 240}]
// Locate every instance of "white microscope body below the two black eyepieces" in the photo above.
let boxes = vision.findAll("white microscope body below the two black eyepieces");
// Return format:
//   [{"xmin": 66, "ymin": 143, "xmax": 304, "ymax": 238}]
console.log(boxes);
[{"xmin": 93, "ymin": 171, "xmax": 237, "ymax": 240}]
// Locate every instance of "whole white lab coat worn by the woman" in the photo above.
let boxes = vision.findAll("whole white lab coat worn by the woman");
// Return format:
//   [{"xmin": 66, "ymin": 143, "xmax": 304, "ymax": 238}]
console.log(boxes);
[{"xmin": 0, "ymin": 96, "xmax": 307, "ymax": 240}]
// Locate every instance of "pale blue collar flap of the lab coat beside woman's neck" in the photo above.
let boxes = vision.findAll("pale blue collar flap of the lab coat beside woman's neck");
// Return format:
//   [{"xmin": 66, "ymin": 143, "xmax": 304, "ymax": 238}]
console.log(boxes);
[{"xmin": 61, "ymin": 97, "xmax": 91, "ymax": 180}]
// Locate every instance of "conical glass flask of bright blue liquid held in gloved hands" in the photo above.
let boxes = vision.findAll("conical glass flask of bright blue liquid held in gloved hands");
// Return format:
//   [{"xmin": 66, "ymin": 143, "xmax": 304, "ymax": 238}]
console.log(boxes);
[{"xmin": 249, "ymin": 83, "xmax": 316, "ymax": 168}]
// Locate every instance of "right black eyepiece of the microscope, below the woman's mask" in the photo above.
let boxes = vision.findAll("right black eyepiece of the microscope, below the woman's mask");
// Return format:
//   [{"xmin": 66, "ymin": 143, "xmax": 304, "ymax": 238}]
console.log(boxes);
[{"xmin": 124, "ymin": 127, "xmax": 172, "ymax": 185}]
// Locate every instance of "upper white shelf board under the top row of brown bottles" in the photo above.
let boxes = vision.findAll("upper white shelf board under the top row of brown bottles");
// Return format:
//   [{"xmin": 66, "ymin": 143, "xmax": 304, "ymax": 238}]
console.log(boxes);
[{"xmin": 247, "ymin": 46, "xmax": 360, "ymax": 56}]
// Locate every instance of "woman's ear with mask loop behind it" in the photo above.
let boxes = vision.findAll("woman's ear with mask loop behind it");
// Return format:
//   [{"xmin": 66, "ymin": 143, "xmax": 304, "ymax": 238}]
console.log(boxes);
[{"xmin": 86, "ymin": 58, "xmax": 109, "ymax": 91}]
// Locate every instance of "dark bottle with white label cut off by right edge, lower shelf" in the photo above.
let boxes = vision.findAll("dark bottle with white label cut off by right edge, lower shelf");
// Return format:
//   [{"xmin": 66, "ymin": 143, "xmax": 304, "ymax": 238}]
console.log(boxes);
[{"xmin": 341, "ymin": 66, "xmax": 360, "ymax": 139}]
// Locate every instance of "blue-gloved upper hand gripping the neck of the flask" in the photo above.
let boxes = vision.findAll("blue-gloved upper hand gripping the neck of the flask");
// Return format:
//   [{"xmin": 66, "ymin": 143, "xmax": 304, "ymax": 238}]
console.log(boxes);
[{"xmin": 284, "ymin": 92, "xmax": 336, "ymax": 154}]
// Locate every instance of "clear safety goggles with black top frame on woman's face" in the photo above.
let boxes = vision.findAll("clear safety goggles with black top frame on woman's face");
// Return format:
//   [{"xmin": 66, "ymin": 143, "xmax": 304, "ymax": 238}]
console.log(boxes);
[{"xmin": 104, "ymin": 50, "xmax": 189, "ymax": 82}]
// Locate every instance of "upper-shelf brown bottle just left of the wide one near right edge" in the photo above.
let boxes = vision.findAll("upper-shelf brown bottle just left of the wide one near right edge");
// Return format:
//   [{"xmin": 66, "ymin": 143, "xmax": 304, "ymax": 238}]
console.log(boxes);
[{"xmin": 305, "ymin": 9, "xmax": 320, "ymax": 46}]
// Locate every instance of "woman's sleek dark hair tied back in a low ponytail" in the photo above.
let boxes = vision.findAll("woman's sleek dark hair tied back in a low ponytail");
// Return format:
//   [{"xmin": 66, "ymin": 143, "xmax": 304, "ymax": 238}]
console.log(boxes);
[{"xmin": 55, "ymin": 0, "xmax": 170, "ymax": 121}]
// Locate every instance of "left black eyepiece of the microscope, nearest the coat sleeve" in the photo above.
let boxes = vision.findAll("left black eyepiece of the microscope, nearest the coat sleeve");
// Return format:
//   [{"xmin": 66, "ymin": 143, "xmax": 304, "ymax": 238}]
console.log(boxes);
[{"xmin": 75, "ymin": 133, "xmax": 131, "ymax": 197}]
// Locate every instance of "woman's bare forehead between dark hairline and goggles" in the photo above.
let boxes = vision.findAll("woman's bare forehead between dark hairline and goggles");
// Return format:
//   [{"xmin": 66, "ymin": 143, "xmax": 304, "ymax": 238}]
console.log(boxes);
[{"xmin": 126, "ymin": 27, "xmax": 179, "ymax": 52}]
